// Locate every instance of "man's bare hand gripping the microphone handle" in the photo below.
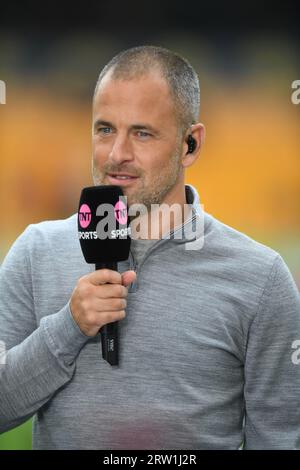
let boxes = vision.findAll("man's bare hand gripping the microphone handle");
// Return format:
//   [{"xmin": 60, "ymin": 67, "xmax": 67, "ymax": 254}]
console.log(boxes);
[{"xmin": 70, "ymin": 269, "xmax": 136, "ymax": 336}]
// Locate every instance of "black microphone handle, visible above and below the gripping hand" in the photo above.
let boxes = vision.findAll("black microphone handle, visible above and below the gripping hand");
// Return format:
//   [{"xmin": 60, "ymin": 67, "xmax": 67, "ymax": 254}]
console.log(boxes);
[{"xmin": 95, "ymin": 261, "xmax": 119, "ymax": 366}]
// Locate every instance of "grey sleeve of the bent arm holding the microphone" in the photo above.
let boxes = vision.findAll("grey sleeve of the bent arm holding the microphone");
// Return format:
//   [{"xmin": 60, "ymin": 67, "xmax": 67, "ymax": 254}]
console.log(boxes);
[{"xmin": 0, "ymin": 225, "xmax": 89, "ymax": 432}]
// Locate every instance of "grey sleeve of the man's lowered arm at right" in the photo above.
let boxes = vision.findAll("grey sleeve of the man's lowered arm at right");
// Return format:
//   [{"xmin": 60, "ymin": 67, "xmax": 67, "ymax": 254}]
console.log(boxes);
[{"xmin": 244, "ymin": 255, "xmax": 300, "ymax": 449}]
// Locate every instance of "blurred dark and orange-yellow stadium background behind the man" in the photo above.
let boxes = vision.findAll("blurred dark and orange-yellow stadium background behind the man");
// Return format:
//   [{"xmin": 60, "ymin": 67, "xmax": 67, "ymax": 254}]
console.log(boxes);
[{"xmin": 0, "ymin": 1, "xmax": 300, "ymax": 449}]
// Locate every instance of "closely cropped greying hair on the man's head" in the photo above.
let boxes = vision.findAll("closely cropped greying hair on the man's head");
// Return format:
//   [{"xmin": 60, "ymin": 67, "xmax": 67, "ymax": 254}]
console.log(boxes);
[{"xmin": 94, "ymin": 46, "xmax": 200, "ymax": 133}]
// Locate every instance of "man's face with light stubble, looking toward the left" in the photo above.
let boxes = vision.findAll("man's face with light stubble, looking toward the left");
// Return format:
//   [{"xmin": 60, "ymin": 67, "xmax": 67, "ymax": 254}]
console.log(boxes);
[{"xmin": 93, "ymin": 73, "xmax": 184, "ymax": 208}]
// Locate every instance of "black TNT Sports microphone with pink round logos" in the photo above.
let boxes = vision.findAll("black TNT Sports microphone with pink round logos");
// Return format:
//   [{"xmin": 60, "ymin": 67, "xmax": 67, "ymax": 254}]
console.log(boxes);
[{"xmin": 78, "ymin": 185, "xmax": 131, "ymax": 366}]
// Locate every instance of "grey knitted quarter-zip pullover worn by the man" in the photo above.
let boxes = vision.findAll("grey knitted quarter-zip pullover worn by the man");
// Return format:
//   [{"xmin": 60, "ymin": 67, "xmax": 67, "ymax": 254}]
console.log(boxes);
[{"xmin": 0, "ymin": 185, "xmax": 300, "ymax": 449}]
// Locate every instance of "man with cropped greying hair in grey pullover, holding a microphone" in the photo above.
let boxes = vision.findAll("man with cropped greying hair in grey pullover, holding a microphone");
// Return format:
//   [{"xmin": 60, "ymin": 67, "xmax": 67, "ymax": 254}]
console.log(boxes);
[{"xmin": 0, "ymin": 46, "xmax": 300, "ymax": 449}]
